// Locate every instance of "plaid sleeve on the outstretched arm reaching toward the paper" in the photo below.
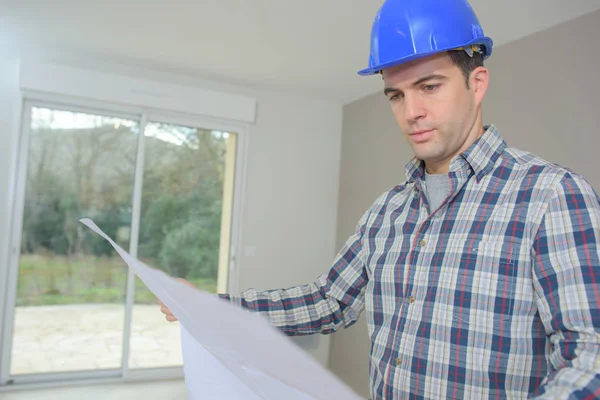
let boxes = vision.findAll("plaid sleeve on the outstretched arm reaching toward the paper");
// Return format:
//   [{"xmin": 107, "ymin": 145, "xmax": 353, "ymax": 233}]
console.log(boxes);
[{"xmin": 220, "ymin": 205, "xmax": 370, "ymax": 336}]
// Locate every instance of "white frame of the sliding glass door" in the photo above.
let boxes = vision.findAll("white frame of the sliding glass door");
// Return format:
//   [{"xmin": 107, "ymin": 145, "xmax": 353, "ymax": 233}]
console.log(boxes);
[{"xmin": 0, "ymin": 66, "xmax": 255, "ymax": 393}]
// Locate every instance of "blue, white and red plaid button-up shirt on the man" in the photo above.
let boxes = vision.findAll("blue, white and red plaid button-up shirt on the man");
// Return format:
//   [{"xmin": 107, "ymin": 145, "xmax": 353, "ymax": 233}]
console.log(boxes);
[{"xmin": 222, "ymin": 126, "xmax": 600, "ymax": 399}]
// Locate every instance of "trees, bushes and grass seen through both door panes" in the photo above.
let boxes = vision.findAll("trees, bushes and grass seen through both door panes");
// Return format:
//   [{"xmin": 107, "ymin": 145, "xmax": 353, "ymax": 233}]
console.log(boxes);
[{"xmin": 18, "ymin": 116, "xmax": 226, "ymax": 305}]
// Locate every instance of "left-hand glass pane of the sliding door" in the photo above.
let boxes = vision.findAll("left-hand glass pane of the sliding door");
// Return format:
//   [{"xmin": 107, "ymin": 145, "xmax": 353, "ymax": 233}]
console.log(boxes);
[{"xmin": 11, "ymin": 107, "xmax": 139, "ymax": 375}]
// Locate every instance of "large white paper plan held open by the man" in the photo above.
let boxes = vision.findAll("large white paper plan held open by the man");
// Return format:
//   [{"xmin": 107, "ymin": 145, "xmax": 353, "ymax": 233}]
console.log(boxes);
[{"xmin": 81, "ymin": 218, "xmax": 361, "ymax": 400}]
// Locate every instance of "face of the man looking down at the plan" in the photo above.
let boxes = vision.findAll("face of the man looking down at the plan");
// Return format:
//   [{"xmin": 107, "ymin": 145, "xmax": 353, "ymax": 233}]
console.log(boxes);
[{"xmin": 383, "ymin": 53, "xmax": 488, "ymax": 173}]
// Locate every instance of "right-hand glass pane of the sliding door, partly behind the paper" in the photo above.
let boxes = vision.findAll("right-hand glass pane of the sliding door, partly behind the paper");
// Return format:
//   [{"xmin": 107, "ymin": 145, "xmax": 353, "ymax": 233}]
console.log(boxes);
[{"xmin": 129, "ymin": 122, "xmax": 236, "ymax": 368}]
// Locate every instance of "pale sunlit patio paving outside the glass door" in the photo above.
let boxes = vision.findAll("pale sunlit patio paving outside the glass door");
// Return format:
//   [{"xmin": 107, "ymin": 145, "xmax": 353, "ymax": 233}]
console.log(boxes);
[{"xmin": 11, "ymin": 304, "xmax": 182, "ymax": 375}]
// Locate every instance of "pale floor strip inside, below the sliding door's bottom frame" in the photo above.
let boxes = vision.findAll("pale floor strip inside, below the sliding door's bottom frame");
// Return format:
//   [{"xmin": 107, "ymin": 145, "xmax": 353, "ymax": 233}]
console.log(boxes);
[{"xmin": 0, "ymin": 380, "xmax": 187, "ymax": 400}]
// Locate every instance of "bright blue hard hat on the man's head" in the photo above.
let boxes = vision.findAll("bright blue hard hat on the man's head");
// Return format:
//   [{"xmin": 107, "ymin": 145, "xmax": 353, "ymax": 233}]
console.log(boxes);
[{"xmin": 358, "ymin": 0, "xmax": 493, "ymax": 75}]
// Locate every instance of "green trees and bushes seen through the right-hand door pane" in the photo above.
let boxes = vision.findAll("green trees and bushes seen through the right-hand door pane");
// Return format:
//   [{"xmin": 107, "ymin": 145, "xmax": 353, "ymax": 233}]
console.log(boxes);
[{"xmin": 139, "ymin": 127, "xmax": 225, "ymax": 279}]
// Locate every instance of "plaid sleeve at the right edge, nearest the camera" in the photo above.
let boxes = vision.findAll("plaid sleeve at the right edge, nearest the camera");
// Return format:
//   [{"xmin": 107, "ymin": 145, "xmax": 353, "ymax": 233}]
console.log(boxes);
[{"xmin": 533, "ymin": 174, "xmax": 600, "ymax": 399}]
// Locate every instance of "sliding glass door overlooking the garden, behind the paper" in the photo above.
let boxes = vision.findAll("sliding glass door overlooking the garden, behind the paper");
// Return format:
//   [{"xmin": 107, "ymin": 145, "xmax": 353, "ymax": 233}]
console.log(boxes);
[{"xmin": 2, "ymin": 102, "xmax": 239, "ymax": 382}]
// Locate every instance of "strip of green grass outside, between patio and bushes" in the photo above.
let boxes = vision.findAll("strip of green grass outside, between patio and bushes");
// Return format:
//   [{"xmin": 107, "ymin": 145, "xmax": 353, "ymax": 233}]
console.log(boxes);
[{"xmin": 17, "ymin": 254, "xmax": 217, "ymax": 306}]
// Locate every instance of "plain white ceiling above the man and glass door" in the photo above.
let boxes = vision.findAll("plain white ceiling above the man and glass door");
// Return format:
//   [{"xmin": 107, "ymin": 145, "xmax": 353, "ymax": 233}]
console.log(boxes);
[{"xmin": 0, "ymin": 0, "xmax": 600, "ymax": 103}]
